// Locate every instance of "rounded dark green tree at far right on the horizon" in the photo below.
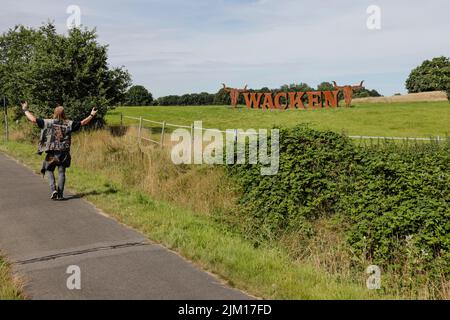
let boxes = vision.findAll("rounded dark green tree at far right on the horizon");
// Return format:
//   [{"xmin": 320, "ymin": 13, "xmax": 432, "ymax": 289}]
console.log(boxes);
[{"xmin": 406, "ymin": 56, "xmax": 450, "ymax": 93}]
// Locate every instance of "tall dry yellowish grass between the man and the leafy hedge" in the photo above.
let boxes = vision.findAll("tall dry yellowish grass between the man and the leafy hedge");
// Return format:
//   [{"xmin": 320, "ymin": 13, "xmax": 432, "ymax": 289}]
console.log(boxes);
[{"xmin": 73, "ymin": 128, "xmax": 237, "ymax": 215}]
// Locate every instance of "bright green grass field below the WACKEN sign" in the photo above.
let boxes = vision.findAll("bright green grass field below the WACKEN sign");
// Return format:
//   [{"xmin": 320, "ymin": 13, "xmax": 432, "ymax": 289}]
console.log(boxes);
[{"xmin": 107, "ymin": 101, "xmax": 450, "ymax": 137}]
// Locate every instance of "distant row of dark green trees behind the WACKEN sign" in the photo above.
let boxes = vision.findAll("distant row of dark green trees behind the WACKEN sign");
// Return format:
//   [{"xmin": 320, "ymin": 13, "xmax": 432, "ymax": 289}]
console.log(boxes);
[{"xmin": 124, "ymin": 82, "xmax": 380, "ymax": 106}]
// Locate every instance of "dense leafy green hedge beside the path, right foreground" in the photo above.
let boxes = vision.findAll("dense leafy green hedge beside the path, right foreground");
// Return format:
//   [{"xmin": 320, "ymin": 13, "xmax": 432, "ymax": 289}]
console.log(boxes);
[{"xmin": 228, "ymin": 126, "xmax": 450, "ymax": 275}]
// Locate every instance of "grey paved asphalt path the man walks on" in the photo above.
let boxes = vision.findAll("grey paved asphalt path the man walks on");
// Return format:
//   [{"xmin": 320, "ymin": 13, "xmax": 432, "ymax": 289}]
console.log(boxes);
[{"xmin": 0, "ymin": 153, "xmax": 249, "ymax": 299}]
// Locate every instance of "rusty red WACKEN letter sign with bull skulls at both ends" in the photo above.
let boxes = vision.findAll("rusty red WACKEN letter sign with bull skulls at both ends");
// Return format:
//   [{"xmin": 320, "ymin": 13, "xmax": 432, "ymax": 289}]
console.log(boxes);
[{"xmin": 222, "ymin": 80, "xmax": 364, "ymax": 110}]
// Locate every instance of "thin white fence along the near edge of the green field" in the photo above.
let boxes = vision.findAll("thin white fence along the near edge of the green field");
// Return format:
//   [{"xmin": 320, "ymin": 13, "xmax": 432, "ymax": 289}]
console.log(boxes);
[{"xmin": 120, "ymin": 114, "xmax": 446, "ymax": 146}]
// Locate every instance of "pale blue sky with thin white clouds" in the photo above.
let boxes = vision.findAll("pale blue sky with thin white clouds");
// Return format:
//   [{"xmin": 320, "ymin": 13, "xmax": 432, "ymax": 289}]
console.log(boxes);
[{"xmin": 0, "ymin": 0, "xmax": 450, "ymax": 97}]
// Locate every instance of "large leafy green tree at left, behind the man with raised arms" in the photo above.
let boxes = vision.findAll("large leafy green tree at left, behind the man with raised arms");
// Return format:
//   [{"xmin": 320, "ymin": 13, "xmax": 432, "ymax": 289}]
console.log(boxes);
[{"xmin": 0, "ymin": 23, "xmax": 130, "ymax": 121}]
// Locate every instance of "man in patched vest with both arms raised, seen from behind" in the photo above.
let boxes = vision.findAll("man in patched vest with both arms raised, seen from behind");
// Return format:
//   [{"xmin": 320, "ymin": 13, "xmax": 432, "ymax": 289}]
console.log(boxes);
[{"xmin": 22, "ymin": 101, "xmax": 97, "ymax": 200}]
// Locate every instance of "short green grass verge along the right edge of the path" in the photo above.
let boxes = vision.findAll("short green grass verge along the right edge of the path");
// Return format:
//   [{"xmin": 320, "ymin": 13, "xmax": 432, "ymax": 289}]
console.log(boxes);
[{"xmin": 0, "ymin": 142, "xmax": 381, "ymax": 299}]
